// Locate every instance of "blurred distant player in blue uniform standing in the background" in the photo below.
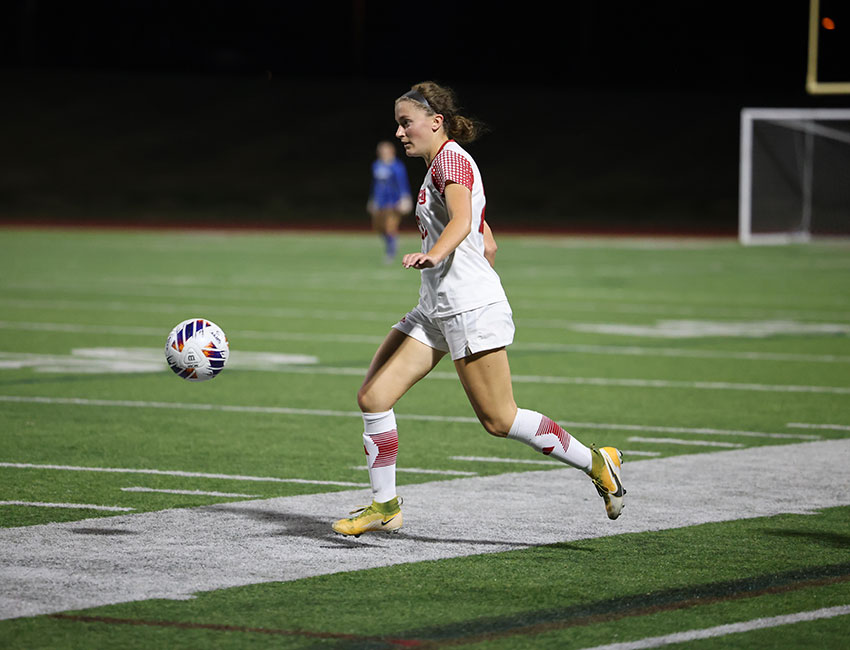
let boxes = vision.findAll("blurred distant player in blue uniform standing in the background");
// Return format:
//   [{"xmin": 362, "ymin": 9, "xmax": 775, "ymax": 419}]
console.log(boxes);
[{"xmin": 366, "ymin": 140, "xmax": 412, "ymax": 262}]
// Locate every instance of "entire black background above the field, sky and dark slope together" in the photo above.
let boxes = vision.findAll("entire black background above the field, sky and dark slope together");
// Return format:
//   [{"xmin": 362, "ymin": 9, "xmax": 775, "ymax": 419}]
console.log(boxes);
[{"xmin": 0, "ymin": 0, "xmax": 850, "ymax": 232}]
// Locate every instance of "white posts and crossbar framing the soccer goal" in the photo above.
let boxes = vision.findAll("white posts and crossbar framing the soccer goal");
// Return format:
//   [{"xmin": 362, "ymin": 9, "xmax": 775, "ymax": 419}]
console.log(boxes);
[{"xmin": 738, "ymin": 108, "xmax": 850, "ymax": 245}]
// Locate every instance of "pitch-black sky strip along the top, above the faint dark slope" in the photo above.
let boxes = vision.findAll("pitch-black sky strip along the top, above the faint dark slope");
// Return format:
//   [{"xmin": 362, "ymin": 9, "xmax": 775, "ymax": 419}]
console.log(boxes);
[{"xmin": 0, "ymin": 0, "xmax": 820, "ymax": 89}]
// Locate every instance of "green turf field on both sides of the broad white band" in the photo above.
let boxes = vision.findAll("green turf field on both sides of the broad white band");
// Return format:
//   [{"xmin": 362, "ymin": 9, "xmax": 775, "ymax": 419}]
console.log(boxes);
[{"xmin": 0, "ymin": 229, "xmax": 850, "ymax": 649}]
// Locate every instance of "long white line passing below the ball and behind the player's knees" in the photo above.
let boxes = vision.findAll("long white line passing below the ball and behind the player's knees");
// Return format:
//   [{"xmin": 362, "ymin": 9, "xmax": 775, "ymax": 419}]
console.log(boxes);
[{"xmin": 0, "ymin": 395, "xmax": 821, "ymax": 440}]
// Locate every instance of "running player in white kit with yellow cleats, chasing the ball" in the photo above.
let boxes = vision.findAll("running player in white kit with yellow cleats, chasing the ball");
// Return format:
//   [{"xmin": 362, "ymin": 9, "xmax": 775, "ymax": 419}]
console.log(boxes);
[{"xmin": 333, "ymin": 82, "xmax": 625, "ymax": 536}]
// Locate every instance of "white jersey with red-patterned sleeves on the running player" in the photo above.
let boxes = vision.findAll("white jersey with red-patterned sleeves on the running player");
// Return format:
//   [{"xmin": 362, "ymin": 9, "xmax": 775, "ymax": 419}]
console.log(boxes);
[{"xmin": 416, "ymin": 140, "xmax": 507, "ymax": 316}]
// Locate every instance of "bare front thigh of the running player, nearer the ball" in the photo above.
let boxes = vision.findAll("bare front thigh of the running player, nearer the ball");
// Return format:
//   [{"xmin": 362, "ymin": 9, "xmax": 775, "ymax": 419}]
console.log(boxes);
[{"xmin": 357, "ymin": 329, "xmax": 445, "ymax": 412}]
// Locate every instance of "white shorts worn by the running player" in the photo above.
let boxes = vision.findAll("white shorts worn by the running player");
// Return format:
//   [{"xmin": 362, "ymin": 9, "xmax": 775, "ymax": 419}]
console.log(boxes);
[{"xmin": 393, "ymin": 300, "xmax": 515, "ymax": 361}]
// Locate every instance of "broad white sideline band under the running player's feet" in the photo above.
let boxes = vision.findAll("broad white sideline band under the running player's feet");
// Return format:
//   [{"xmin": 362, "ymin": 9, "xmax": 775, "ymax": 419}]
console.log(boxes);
[{"xmin": 0, "ymin": 439, "xmax": 850, "ymax": 619}]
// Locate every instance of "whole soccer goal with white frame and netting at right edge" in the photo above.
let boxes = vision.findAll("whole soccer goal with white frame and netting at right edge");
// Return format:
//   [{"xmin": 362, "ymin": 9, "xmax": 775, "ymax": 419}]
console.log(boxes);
[{"xmin": 738, "ymin": 108, "xmax": 850, "ymax": 244}]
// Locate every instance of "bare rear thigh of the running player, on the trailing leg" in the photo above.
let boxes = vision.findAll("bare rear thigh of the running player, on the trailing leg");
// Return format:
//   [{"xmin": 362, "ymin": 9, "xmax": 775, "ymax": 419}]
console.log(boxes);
[{"xmin": 454, "ymin": 348, "xmax": 517, "ymax": 436}]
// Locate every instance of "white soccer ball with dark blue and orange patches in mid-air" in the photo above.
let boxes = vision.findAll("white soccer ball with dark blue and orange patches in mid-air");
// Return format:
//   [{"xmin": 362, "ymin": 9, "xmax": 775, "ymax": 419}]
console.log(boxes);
[{"xmin": 165, "ymin": 318, "xmax": 230, "ymax": 381}]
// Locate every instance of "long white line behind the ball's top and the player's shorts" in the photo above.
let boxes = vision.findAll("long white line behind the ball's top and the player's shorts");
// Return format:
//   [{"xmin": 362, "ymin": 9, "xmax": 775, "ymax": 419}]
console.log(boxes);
[{"xmin": 0, "ymin": 321, "xmax": 850, "ymax": 363}]
